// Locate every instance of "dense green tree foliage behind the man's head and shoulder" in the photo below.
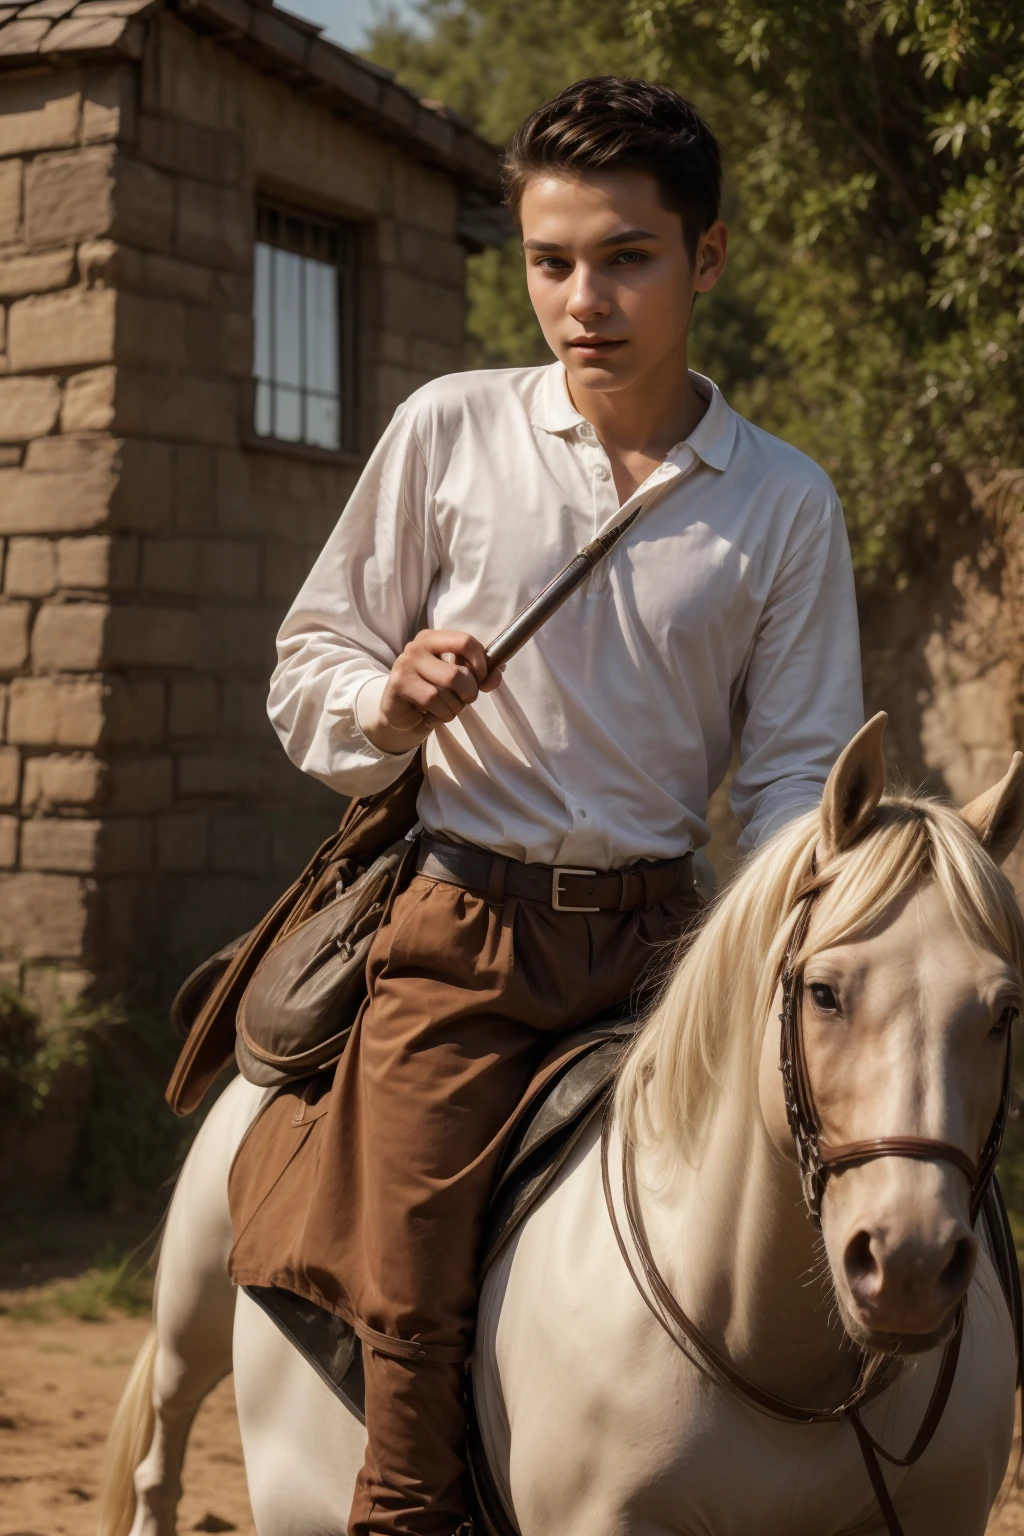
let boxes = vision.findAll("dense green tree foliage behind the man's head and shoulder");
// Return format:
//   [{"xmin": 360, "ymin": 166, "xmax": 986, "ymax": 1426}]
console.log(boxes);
[{"xmin": 363, "ymin": 0, "xmax": 1024, "ymax": 578}]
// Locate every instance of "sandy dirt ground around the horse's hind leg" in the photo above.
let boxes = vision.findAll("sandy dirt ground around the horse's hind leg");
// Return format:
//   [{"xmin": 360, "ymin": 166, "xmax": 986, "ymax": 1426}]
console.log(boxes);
[{"xmin": 0, "ymin": 1315, "xmax": 1024, "ymax": 1536}]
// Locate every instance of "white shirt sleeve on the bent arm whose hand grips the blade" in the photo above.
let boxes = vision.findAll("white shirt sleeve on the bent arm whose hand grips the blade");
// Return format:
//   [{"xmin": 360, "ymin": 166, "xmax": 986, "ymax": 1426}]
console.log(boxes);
[{"xmin": 267, "ymin": 407, "xmax": 436, "ymax": 796}]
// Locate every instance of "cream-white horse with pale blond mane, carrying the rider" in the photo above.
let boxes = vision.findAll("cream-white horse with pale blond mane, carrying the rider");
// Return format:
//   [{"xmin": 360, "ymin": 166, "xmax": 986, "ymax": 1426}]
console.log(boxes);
[{"xmin": 100, "ymin": 717, "xmax": 1024, "ymax": 1536}]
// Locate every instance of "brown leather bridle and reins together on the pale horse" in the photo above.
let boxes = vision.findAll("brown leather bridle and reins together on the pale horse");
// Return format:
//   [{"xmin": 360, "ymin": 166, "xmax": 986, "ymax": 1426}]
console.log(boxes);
[{"xmin": 600, "ymin": 882, "xmax": 1021, "ymax": 1536}]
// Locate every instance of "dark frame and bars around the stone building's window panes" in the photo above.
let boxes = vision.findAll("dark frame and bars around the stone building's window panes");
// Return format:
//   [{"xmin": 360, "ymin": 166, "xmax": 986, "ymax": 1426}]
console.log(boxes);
[{"xmin": 246, "ymin": 192, "xmax": 361, "ymax": 462}]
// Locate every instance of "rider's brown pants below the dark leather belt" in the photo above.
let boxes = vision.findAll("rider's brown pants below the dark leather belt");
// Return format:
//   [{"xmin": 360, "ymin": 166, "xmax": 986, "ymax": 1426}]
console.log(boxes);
[{"xmin": 304, "ymin": 876, "xmax": 699, "ymax": 1536}]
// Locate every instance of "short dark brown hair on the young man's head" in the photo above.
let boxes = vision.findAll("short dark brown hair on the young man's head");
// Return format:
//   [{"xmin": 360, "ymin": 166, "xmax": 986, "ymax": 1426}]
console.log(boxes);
[{"xmin": 502, "ymin": 75, "xmax": 722, "ymax": 257}]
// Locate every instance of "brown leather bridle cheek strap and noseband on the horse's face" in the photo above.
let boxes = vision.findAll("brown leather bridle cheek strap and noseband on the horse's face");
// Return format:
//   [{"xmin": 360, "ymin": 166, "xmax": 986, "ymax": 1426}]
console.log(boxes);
[{"xmin": 778, "ymin": 879, "xmax": 1013, "ymax": 1229}]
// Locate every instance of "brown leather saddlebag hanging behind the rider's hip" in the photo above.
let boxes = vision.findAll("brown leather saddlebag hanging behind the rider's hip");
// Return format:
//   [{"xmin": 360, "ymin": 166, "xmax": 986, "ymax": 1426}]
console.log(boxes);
[{"xmin": 166, "ymin": 759, "xmax": 422, "ymax": 1115}]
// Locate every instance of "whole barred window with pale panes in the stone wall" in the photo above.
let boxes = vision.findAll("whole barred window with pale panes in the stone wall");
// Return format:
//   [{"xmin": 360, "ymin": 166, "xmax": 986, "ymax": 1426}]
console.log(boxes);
[{"xmin": 253, "ymin": 203, "xmax": 356, "ymax": 449}]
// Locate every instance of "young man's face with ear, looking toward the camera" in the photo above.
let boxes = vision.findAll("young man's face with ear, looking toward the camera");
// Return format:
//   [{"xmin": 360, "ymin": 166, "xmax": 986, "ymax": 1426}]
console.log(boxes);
[{"xmin": 520, "ymin": 170, "xmax": 726, "ymax": 392}]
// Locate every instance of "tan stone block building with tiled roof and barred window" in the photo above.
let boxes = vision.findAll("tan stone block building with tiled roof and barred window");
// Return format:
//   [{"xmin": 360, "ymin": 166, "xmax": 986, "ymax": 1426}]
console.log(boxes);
[{"xmin": 0, "ymin": 0, "xmax": 504, "ymax": 1001}]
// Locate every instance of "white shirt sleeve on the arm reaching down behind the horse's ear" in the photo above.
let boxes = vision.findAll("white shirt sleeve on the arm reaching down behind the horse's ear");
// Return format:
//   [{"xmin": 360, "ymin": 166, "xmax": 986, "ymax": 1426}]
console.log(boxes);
[{"xmin": 731, "ymin": 501, "xmax": 864, "ymax": 852}]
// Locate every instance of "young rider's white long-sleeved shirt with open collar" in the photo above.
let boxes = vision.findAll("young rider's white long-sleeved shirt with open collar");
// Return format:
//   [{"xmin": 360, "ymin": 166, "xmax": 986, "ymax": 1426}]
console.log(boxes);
[{"xmin": 269, "ymin": 362, "xmax": 863, "ymax": 869}]
